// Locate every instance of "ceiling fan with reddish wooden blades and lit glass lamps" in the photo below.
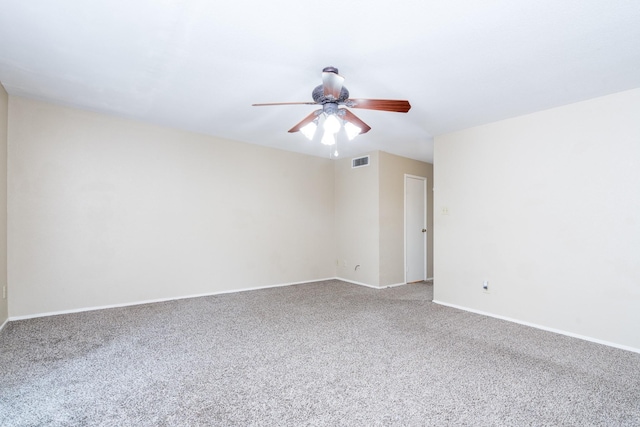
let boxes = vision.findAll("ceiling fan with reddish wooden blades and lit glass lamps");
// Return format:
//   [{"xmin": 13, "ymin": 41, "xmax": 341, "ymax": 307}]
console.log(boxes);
[{"xmin": 252, "ymin": 67, "xmax": 411, "ymax": 145}]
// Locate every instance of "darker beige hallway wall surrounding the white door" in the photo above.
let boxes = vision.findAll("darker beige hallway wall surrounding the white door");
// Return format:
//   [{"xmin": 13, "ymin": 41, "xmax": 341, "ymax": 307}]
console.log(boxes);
[{"xmin": 379, "ymin": 152, "xmax": 433, "ymax": 286}]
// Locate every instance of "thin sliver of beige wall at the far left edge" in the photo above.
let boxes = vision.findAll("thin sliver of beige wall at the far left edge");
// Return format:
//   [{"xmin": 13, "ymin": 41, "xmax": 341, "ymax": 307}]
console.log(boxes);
[{"xmin": 0, "ymin": 84, "xmax": 9, "ymax": 327}]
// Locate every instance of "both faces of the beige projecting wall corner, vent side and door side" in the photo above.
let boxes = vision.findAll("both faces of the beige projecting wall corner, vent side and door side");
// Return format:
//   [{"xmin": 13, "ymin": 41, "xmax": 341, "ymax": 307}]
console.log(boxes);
[{"xmin": 334, "ymin": 151, "xmax": 433, "ymax": 287}]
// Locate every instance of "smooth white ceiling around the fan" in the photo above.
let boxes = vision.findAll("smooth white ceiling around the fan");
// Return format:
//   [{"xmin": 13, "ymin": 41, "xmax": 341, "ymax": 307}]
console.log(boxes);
[{"xmin": 0, "ymin": 0, "xmax": 640, "ymax": 161}]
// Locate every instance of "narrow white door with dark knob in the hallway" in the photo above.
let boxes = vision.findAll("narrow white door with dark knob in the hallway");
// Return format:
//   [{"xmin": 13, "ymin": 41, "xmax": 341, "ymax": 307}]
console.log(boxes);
[{"xmin": 404, "ymin": 175, "xmax": 427, "ymax": 283}]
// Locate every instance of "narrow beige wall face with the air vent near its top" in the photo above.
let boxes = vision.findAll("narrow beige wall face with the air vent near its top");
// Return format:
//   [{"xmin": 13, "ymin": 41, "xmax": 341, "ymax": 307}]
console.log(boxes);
[{"xmin": 333, "ymin": 151, "xmax": 380, "ymax": 287}]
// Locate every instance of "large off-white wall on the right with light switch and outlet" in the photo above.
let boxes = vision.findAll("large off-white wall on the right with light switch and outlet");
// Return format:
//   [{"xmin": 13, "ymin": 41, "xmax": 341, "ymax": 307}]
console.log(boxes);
[{"xmin": 434, "ymin": 89, "xmax": 640, "ymax": 351}]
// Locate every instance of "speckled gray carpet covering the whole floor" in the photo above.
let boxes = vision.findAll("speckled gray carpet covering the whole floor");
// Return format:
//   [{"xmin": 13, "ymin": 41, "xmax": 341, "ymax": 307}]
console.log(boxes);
[{"xmin": 0, "ymin": 281, "xmax": 640, "ymax": 426}]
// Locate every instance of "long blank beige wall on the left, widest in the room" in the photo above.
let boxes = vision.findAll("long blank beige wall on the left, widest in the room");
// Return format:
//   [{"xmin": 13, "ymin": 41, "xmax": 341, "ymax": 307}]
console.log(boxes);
[{"xmin": 8, "ymin": 96, "xmax": 335, "ymax": 317}]
